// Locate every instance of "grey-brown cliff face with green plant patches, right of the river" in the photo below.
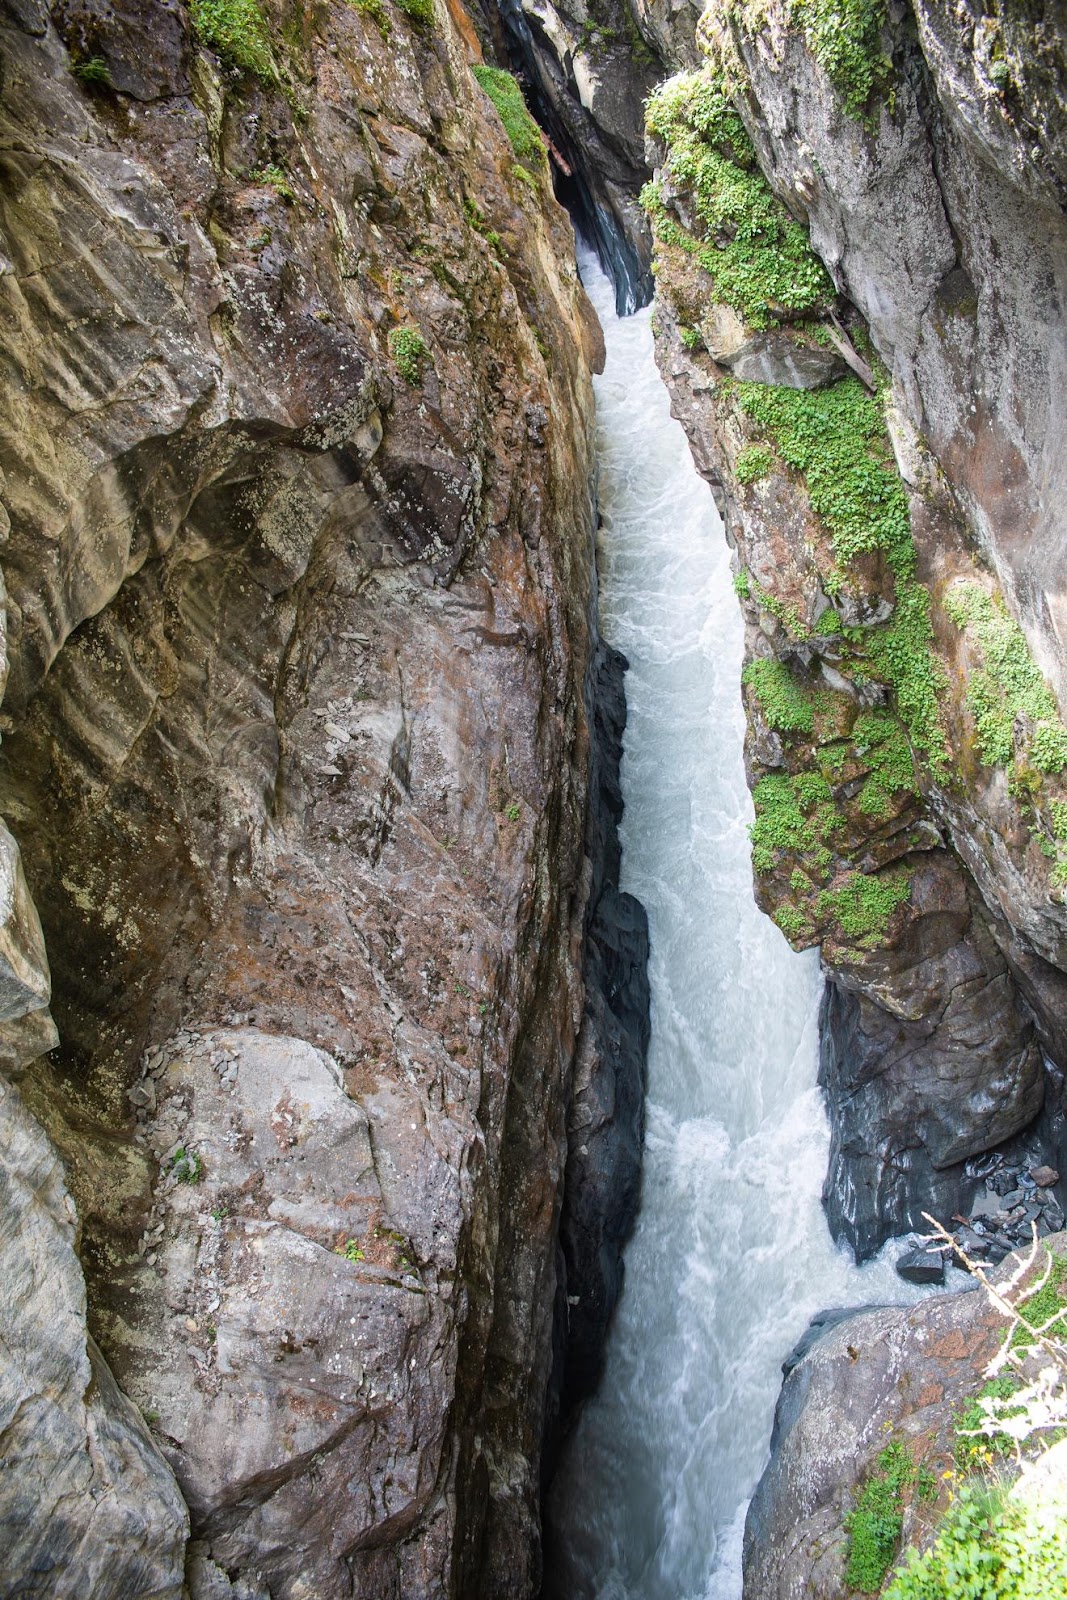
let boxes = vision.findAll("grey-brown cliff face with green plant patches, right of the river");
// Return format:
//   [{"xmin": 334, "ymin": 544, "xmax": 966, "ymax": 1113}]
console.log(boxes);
[{"xmin": 639, "ymin": 3, "xmax": 1067, "ymax": 1256}]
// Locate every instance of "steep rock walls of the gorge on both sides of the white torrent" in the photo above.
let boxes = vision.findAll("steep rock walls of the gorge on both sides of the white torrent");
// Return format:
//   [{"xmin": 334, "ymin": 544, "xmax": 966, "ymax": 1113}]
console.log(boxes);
[{"xmin": 0, "ymin": 0, "xmax": 1067, "ymax": 1600}]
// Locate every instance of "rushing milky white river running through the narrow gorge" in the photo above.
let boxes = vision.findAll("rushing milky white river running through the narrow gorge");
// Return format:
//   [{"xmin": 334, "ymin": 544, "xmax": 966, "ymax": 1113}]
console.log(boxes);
[{"xmin": 549, "ymin": 259, "xmax": 912, "ymax": 1600}]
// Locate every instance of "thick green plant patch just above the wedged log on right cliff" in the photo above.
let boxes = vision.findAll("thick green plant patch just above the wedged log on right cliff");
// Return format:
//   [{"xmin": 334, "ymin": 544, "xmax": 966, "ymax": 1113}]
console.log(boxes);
[{"xmin": 641, "ymin": 67, "xmax": 833, "ymax": 328}]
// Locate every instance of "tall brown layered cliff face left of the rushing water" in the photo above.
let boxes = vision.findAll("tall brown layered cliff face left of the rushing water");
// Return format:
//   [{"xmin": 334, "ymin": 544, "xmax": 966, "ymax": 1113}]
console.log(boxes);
[{"xmin": 0, "ymin": 0, "xmax": 607, "ymax": 1600}]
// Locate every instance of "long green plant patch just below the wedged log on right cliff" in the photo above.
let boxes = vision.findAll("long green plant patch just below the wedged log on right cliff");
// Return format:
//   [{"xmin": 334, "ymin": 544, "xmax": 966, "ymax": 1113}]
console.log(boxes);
[{"xmin": 734, "ymin": 378, "xmax": 947, "ymax": 776}]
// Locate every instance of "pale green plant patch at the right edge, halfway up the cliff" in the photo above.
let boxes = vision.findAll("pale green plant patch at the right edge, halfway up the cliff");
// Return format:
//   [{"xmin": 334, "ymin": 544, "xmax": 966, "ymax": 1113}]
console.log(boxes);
[{"xmin": 945, "ymin": 584, "xmax": 1067, "ymax": 773}]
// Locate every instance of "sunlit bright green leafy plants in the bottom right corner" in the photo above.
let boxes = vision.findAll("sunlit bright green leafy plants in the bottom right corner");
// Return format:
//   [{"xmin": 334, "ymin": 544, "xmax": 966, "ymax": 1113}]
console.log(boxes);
[{"xmin": 886, "ymin": 1485, "xmax": 1067, "ymax": 1600}]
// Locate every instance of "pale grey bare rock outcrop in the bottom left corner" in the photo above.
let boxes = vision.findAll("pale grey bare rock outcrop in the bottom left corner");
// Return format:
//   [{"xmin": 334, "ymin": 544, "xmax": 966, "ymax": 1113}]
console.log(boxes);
[{"xmin": 0, "ymin": 1082, "xmax": 189, "ymax": 1600}]
